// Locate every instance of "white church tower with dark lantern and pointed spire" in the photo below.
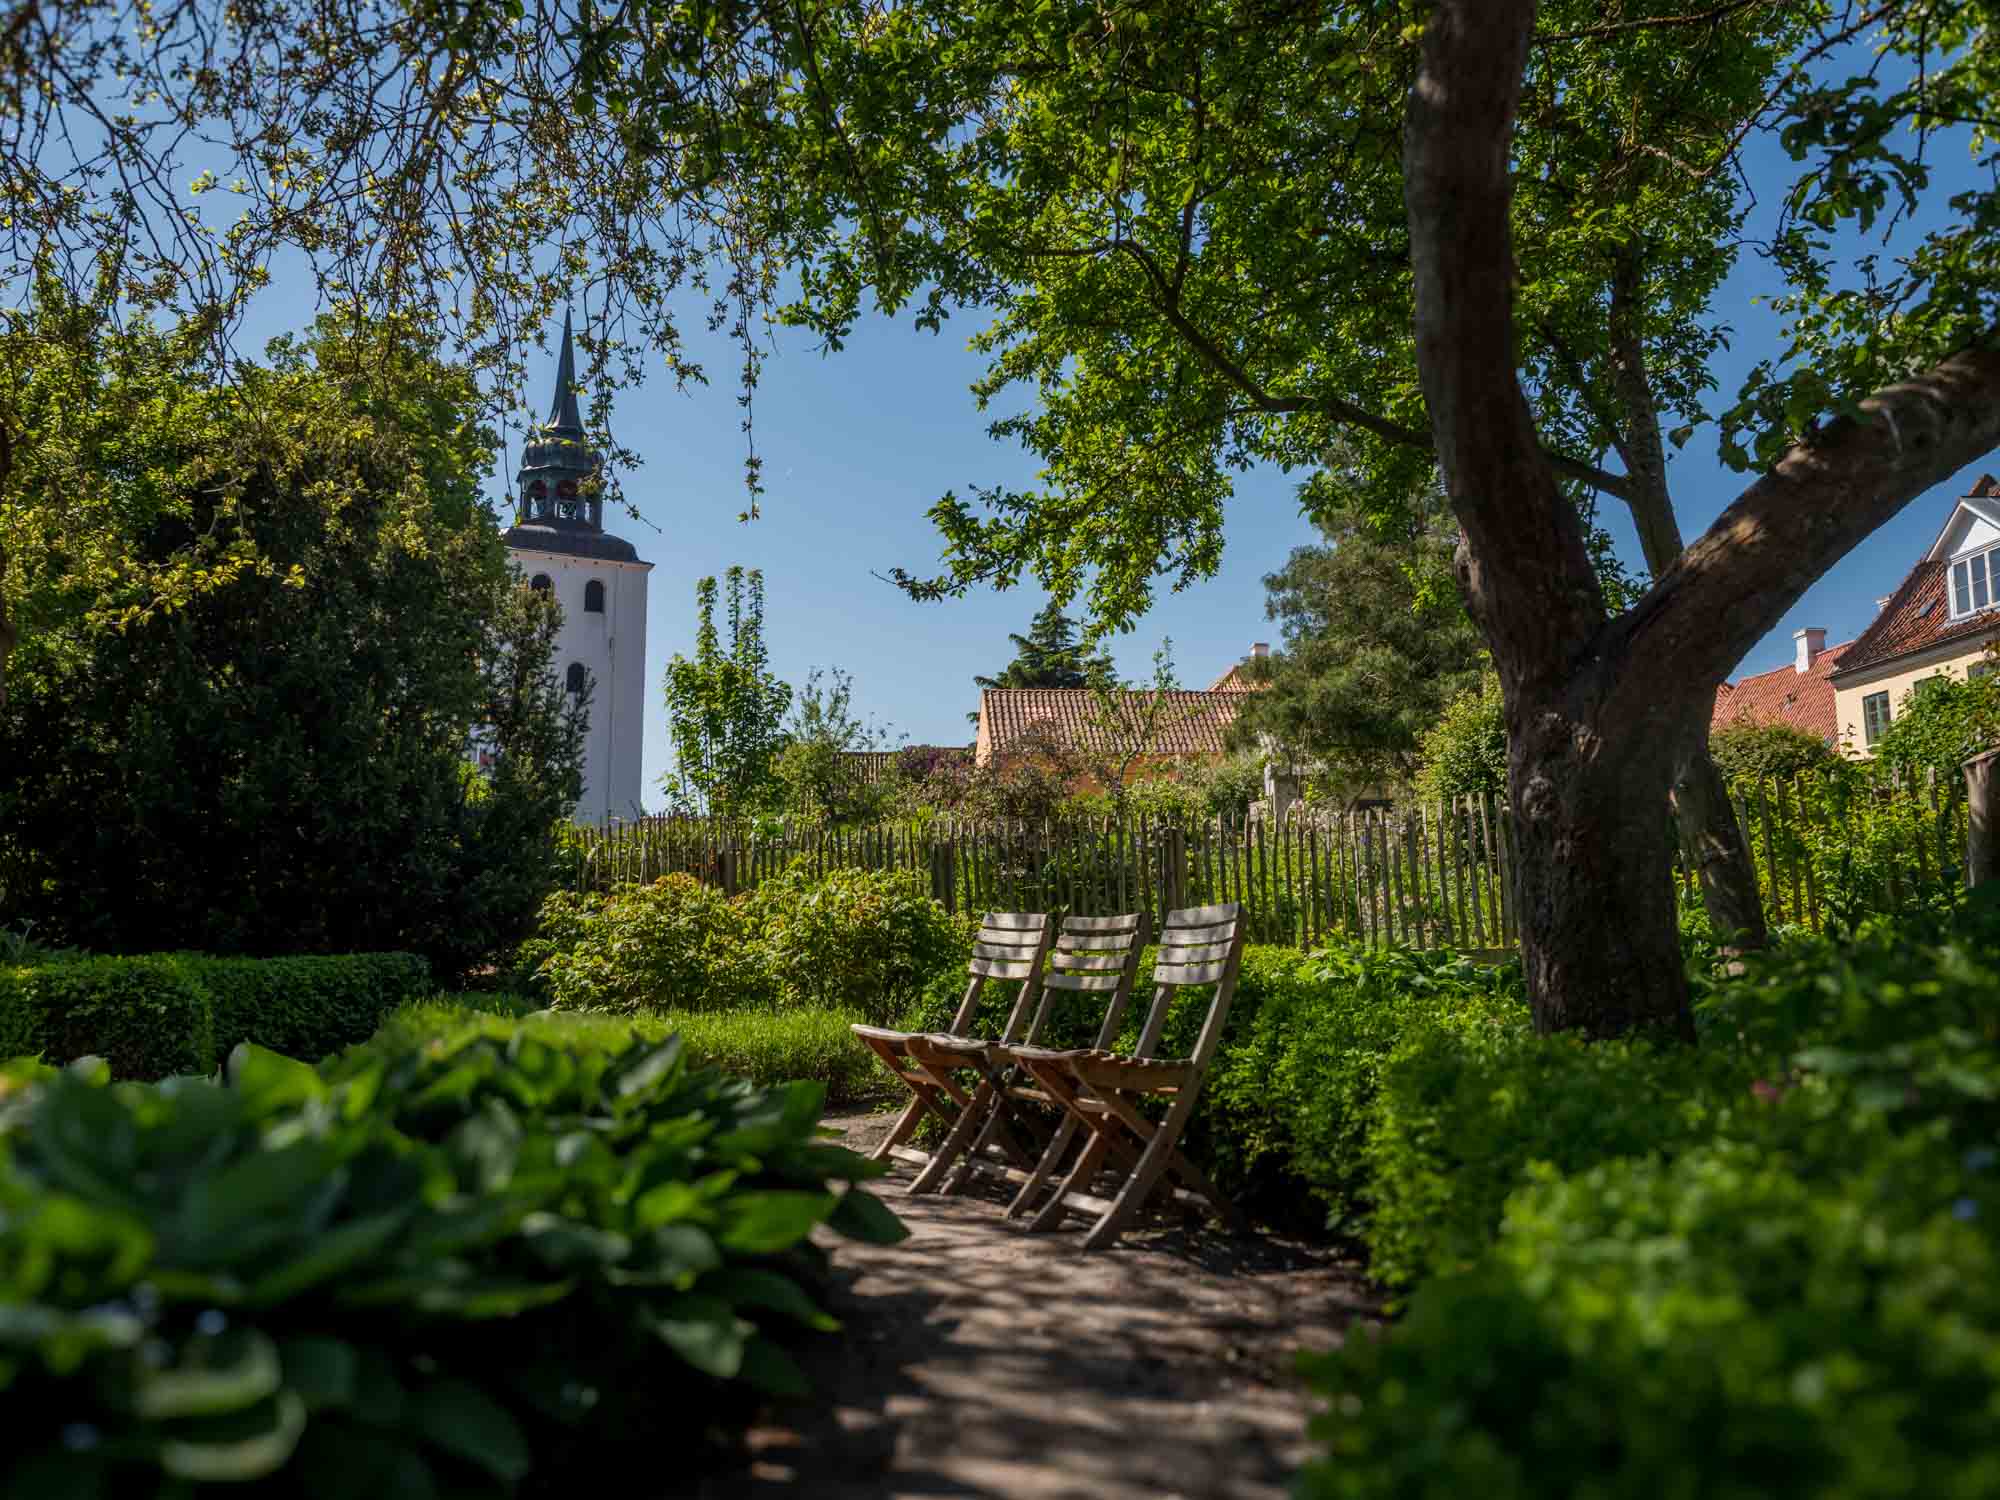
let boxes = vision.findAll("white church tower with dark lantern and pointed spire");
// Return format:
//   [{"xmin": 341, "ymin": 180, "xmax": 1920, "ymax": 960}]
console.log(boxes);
[{"xmin": 506, "ymin": 314, "xmax": 652, "ymax": 824}]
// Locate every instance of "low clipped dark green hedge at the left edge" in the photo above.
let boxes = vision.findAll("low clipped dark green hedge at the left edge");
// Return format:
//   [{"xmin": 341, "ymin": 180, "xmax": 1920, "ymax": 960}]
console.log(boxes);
[{"xmin": 0, "ymin": 954, "xmax": 430, "ymax": 1078}]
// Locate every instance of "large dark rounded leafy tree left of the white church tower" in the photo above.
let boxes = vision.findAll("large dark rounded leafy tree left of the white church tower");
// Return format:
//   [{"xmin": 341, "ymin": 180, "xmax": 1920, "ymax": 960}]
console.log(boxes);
[{"xmin": 0, "ymin": 312, "xmax": 584, "ymax": 976}]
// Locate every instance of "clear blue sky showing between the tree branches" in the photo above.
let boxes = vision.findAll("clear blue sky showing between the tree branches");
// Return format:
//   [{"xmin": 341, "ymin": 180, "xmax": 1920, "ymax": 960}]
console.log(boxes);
[{"xmin": 536, "ymin": 101, "xmax": 2000, "ymax": 812}]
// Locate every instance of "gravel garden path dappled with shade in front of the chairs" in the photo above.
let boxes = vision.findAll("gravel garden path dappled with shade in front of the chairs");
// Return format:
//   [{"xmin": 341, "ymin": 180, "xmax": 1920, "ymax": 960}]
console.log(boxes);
[{"xmin": 694, "ymin": 1114, "xmax": 1380, "ymax": 1500}]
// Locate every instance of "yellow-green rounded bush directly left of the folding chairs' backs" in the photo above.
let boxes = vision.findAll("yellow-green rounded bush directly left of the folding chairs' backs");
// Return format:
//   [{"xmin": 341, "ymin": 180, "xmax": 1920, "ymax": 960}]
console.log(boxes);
[{"xmin": 750, "ymin": 864, "xmax": 972, "ymax": 1026}]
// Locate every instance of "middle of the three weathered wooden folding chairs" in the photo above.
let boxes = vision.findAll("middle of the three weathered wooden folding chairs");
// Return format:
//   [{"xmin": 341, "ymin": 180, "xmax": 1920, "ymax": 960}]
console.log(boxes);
[{"xmin": 910, "ymin": 912, "xmax": 1146, "ymax": 1194}]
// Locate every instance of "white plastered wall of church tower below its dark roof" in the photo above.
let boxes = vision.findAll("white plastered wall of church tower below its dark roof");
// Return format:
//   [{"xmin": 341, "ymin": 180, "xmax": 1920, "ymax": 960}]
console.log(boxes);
[{"xmin": 508, "ymin": 548, "xmax": 652, "ymax": 824}]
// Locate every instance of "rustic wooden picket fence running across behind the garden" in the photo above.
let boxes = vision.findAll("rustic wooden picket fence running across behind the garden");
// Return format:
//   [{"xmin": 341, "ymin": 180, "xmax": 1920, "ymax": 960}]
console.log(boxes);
[{"xmin": 576, "ymin": 776, "xmax": 1966, "ymax": 954}]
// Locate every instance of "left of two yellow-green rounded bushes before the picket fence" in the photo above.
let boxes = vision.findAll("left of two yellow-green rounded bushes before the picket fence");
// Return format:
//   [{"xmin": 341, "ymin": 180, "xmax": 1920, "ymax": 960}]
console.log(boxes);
[{"xmin": 538, "ymin": 874, "xmax": 772, "ymax": 1014}]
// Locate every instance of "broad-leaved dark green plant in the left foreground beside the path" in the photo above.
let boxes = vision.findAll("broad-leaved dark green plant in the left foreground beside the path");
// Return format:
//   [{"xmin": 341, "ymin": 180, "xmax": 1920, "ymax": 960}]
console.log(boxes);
[{"xmin": 0, "ymin": 1026, "xmax": 902, "ymax": 1496}]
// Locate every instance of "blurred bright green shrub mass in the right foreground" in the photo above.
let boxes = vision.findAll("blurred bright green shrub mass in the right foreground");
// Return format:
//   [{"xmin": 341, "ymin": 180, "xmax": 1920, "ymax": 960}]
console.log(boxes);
[{"xmin": 1302, "ymin": 902, "xmax": 2000, "ymax": 1500}]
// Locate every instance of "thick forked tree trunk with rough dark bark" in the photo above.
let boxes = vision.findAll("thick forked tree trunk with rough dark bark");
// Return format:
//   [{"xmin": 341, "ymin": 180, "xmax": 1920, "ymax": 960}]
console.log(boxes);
[{"xmin": 1404, "ymin": 0, "xmax": 2000, "ymax": 1036}]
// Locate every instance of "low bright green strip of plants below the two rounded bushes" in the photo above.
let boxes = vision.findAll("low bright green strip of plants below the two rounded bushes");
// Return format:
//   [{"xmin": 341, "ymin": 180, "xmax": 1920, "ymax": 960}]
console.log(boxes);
[{"xmin": 382, "ymin": 994, "xmax": 894, "ymax": 1108}]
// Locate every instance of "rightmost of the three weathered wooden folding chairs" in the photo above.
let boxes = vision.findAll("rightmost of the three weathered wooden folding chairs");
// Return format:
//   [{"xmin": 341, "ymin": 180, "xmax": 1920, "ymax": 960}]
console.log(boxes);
[{"xmin": 1010, "ymin": 902, "xmax": 1244, "ymax": 1250}]
